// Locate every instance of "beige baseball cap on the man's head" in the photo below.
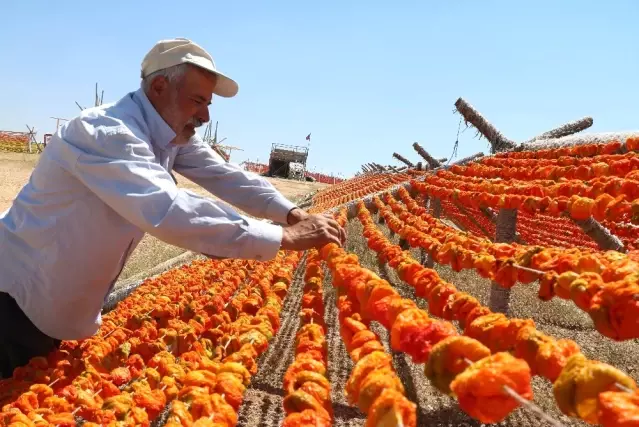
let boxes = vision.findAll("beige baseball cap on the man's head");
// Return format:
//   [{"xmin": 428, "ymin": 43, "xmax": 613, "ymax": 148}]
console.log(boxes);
[{"xmin": 142, "ymin": 38, "xmax": 238, "ymax": 98}]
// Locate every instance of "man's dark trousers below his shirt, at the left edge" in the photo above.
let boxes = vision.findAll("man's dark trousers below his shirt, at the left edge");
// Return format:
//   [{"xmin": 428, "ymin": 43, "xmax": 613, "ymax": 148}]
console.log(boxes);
[{"xmin": 0, "ymin": 292, "xmax": 60, "ymax": 378}]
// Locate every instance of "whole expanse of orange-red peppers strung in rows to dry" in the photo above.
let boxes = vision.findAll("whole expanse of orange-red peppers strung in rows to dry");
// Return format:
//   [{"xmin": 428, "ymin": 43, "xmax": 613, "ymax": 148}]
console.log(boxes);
[{"xmin": 0, "ymin": 138, "xmax": 639, "ymax": 427}]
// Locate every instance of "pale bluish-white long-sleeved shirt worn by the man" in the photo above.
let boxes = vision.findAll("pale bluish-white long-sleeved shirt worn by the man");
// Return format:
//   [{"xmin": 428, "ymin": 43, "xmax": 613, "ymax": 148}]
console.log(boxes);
[{"xmin": 0, "ymin": 89, "xmax": 295, "ymax": 340}]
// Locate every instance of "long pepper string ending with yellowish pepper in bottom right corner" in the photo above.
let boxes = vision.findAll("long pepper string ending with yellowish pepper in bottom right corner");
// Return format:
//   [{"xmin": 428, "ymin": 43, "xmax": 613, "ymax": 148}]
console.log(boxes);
[{"xmin": 358, "ymin": 203, "xmax": 639, "ymax": 427}]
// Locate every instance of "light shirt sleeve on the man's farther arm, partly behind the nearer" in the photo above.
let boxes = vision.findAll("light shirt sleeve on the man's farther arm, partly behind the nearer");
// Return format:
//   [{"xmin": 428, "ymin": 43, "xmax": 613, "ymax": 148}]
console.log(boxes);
[{"xmin": 173, "ymin": 136, "xmax": 296, "ymax": 224}]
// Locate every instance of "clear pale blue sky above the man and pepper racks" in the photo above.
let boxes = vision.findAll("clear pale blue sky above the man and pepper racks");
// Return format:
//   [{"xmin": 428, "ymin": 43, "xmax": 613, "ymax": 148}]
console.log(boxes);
[{"xmin": 0, "ymin": 0, "xmax": 639, "ymax": 176}]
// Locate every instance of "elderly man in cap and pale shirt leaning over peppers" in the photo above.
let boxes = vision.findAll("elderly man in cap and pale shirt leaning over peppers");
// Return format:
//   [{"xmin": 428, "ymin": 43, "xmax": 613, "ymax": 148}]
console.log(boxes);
[{"xmin": 0, "ymin": 39, "xmax": 344, "ymax": 377}]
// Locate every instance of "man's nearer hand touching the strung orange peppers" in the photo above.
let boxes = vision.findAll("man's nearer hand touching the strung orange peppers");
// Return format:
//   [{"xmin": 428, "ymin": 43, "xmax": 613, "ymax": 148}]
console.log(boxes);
[{"xmin": 282, "ymin": 215, "xmax": 346, "ymax": 251}]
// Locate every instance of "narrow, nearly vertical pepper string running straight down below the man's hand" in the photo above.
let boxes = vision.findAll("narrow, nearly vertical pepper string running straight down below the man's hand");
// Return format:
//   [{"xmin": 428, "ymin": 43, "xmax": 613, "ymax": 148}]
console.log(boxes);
[{"xmin": 282, "ymin": 250, "xmax": 333, "ymax": 427}]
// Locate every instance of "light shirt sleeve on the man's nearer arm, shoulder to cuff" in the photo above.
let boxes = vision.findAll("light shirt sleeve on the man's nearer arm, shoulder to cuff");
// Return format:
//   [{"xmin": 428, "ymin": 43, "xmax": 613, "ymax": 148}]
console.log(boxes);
[{"xmin": 67, "ymin": 127, "xmax": 282, "ymax": 260}]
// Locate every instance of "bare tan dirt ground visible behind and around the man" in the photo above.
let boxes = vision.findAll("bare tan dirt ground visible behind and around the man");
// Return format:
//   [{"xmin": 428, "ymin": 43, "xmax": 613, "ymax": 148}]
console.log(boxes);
[{"xmin": 0, "ymin": 152, "xmax": 326, "ymax": 281}]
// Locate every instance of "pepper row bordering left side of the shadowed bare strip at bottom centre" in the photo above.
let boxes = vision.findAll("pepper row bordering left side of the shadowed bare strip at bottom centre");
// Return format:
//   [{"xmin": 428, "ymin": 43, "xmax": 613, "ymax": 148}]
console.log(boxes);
[{"xmin": 109, "ymin": 256, "xmax": 293, "ymax": 425}]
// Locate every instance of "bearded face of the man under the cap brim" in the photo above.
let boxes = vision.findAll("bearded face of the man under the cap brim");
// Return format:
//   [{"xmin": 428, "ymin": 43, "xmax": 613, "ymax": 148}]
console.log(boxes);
[{"xmin": 147, "ymin": 66, "xmax": 216, "ymax": 144}]
